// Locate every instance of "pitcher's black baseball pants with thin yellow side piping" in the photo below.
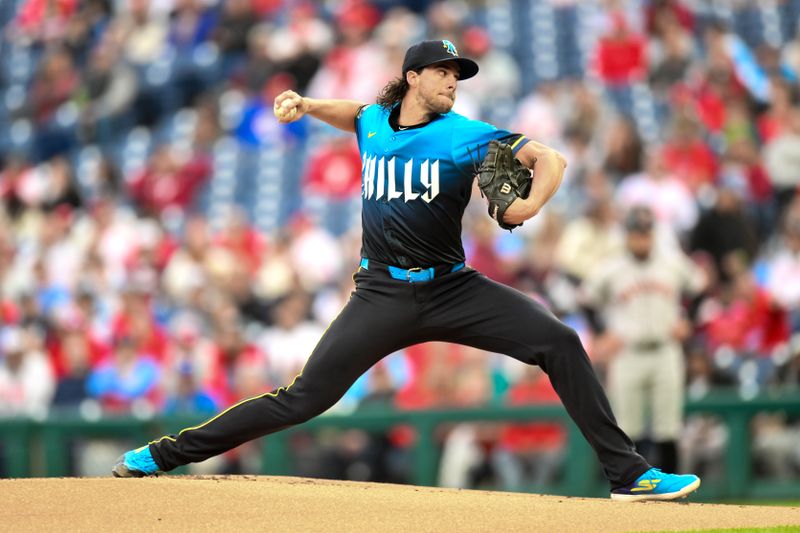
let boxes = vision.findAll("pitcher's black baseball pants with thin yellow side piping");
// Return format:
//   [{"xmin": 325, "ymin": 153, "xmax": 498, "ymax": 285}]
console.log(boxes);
[{"xmin": 150, "ymin": 264, "xmax": 649, "ymax": 488}]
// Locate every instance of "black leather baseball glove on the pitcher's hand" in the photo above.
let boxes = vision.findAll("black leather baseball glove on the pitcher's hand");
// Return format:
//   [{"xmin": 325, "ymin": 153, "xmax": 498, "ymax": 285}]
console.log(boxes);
[{"xmin": 478, "ymin": 141, "xmax": 533, "ymax": 230}]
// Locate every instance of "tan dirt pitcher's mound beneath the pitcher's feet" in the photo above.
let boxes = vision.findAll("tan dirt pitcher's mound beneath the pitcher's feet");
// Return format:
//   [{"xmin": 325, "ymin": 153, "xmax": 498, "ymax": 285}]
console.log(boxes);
[{"xmin": 0, "ymin": 476, "xmax": 800, "ymax": 533}]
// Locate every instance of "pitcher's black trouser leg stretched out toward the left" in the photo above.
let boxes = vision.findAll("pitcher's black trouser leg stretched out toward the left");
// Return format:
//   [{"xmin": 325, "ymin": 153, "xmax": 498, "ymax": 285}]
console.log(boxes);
[{"xmin": 150, "ymin": 274, "xmax": 416, "ymax": 471}]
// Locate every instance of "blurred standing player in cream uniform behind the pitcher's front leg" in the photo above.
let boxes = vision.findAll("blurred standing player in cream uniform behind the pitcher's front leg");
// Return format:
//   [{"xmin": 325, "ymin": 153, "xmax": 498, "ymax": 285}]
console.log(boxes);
[{"xmin": 583, "ymin": 207, "xmax": 704, "ymax": 471}]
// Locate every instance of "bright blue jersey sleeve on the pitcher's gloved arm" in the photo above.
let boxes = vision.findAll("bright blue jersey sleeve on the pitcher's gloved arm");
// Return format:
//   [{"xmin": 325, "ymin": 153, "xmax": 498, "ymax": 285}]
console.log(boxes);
[{"xmin": 452, "ymin": 118, "xmax": 528, "ymax": 176}]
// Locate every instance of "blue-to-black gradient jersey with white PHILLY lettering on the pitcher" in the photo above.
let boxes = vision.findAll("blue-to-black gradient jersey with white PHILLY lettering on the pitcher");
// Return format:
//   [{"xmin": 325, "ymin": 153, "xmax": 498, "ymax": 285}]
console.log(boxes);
[{"xmin": 355, "ymin": 104, "xmax": 527, "ymax": 268}]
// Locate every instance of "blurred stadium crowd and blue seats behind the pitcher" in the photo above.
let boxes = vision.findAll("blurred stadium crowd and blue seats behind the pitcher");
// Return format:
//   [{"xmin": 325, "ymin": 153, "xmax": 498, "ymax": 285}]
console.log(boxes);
[{"xmin": 0, "ymin": 0, "xmax": 800, "ymax": 486}]
